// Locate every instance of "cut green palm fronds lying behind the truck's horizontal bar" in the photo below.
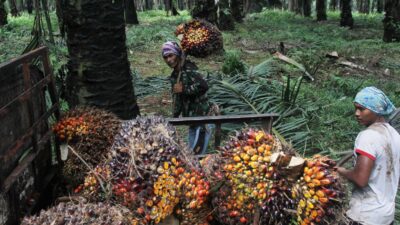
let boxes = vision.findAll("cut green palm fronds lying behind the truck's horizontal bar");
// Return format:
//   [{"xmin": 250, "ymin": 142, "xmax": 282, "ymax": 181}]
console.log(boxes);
[{"xmin": 209, "ymin": 67, "xmax": 313, "ymax": 149}]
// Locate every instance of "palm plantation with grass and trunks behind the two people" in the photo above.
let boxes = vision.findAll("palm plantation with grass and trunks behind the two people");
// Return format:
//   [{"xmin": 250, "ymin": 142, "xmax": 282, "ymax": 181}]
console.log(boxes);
[{"xmin": 0, "ymin": 0, "xmax": 400, "ymax": 223}]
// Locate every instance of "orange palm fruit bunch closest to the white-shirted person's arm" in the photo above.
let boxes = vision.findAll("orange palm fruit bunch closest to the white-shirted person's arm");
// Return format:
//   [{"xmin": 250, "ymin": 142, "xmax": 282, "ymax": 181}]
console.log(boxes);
[{"xmin": 292, "ymin": 155, "xmax": 344, "ymax": 225}]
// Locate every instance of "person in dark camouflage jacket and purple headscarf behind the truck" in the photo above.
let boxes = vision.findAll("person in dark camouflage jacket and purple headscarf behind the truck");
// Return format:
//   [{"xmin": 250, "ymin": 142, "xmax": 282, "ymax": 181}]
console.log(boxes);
[{"xmin": 162, "ymin": 41, "xmax": 219, "ymax": 154}]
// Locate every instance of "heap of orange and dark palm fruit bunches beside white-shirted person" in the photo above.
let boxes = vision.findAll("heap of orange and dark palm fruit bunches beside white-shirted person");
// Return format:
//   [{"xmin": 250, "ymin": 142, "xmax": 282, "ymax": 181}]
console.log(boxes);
[{"xmin": 212, "ymin": 129, "xmax": 342, "ymax": 225}]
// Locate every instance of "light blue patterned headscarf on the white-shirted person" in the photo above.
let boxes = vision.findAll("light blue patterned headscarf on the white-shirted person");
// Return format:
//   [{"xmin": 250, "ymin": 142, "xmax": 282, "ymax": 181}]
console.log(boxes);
[{"xmin": 354, "ymin": 87, "xmax": 396, "ymax": 116}]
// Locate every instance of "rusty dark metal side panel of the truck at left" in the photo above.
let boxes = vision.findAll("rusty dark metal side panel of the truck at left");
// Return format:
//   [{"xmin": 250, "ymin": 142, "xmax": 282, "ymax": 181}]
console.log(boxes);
[{"xmin": 0, "ymin": 47, "xmax": 60, "ymax": 225}]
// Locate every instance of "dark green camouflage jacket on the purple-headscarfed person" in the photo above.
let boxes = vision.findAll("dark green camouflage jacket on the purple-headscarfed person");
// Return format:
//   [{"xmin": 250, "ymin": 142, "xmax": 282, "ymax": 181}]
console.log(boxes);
[{"xmin": 170, "ymin": 61, "xmax": 210, "ymax": 117}]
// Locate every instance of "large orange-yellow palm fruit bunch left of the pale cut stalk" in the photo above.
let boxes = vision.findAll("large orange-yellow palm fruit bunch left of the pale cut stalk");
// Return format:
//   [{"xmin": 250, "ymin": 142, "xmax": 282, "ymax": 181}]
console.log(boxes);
[{"xmin": 213, "ymin": 129, "xmax": 279, "ymax": 224}]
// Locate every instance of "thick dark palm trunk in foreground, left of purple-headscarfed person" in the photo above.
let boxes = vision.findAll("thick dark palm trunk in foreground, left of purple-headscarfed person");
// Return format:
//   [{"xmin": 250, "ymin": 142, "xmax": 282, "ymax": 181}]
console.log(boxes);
[{"xmin": 62, "ymin": 0, "xmax": 139, "ymax": 119}]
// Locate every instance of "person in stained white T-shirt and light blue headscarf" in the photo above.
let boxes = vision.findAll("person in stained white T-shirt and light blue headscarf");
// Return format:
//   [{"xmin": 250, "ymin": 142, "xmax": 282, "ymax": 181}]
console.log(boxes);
[{"xmin": 337, "ymin": 87, "xmax": 400, "ymax": 225}]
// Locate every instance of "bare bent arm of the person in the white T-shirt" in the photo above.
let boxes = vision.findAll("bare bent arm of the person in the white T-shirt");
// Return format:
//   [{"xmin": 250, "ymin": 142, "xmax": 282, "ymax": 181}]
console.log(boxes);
[{"xmin": 337, "ymin": 154, "xmax": 374, "ymax": 188}]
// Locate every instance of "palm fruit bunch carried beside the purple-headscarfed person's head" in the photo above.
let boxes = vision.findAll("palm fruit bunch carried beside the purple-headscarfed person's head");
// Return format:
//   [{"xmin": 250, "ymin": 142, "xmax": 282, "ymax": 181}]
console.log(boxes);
[{"xmin": 175, "ymin": 19, "xmax": 223, "ymax": 57}]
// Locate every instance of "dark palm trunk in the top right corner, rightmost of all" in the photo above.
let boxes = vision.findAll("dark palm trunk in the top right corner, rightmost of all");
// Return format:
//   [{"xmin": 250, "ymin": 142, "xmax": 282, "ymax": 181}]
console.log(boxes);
[{"xmin": 383, "ymin": 0, "xmax": 400, "ymax": 42}]
